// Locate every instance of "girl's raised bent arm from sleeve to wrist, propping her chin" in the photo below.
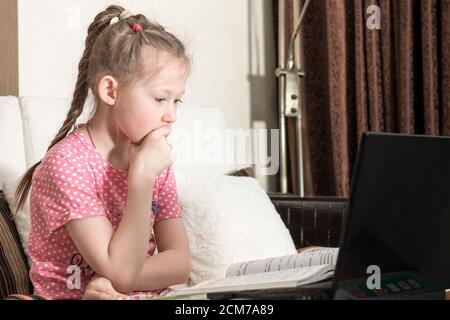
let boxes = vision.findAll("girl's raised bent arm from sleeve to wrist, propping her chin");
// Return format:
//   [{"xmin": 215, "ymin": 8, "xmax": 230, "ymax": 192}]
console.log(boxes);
[{"xmin": 66, "ymin": 171, "xmax": 155, "ymax": 293}]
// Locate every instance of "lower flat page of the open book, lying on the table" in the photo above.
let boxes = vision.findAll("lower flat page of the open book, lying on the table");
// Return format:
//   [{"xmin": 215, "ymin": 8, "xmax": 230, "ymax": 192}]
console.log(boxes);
[{"xmin": 171, "ymin": 265, "xmax": 334, "ymax": 295}]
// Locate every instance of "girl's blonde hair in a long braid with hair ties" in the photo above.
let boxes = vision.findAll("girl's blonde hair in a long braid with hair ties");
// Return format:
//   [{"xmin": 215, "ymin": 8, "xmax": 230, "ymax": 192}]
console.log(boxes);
[{"xmin": 15, "ymin": 5, "xmax": 190, "ymax": 212}]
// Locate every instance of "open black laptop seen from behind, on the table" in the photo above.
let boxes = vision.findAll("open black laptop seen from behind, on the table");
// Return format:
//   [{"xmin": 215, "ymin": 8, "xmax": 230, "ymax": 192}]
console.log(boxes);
[{"xmin": 207, "ymin": 132, "xmax": 450, "ymax": 300}]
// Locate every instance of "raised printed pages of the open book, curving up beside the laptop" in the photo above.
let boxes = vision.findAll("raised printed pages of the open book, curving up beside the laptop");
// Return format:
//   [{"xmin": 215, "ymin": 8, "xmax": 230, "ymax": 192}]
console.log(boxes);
[{"xmin": 225, "ymin": 247, "xmax": 339, "ymax": 277}]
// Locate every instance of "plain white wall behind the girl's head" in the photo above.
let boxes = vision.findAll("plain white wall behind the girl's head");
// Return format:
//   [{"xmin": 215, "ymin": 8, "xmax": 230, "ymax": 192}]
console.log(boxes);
[{"xmin": 18, "ymin": 0, "xmax": 276, "ymax": 189}]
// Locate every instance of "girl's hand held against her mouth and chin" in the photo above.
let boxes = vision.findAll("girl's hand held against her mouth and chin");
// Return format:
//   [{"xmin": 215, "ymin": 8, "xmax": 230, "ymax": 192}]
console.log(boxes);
[{"xmin": 129, "ymin": 126, "xmax": 175, "ymax": 179}]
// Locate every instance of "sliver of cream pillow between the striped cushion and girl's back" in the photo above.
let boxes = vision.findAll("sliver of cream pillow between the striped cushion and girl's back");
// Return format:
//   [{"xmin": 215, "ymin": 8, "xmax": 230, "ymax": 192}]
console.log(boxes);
[{"xmin": 3, "ymin": 179, "xmax": 31, "ymax": 267}]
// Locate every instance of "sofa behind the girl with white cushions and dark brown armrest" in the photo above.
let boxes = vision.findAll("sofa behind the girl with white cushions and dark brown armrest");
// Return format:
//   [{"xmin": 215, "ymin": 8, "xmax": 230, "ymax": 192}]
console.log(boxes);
[{"xmin": 0, "ymin": 96, "xmax": 347, "ymax": 299}]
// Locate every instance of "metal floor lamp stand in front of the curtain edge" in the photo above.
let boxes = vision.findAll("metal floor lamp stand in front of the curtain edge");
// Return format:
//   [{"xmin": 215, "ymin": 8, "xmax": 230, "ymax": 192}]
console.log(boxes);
[{"xmin": 275, "ymin": 0, "xmax": 310, "ymax": 197}]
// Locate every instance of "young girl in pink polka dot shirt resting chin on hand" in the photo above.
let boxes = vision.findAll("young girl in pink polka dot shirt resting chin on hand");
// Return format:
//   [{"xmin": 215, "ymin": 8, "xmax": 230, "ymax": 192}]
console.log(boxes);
[{"xmin": 16, "ymin": 6, "xmax": 190, "ymax": 299}]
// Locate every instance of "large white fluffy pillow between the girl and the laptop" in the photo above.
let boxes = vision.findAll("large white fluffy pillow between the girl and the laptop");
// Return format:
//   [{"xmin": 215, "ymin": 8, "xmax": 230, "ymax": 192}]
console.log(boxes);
[{"xmin": 175, "ymin": 171, "xmax": 297, "ymax": 286}]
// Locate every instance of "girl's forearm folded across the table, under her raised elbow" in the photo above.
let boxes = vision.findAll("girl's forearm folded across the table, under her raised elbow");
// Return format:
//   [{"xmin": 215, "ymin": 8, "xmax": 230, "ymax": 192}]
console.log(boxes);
[{"xmin": 136, "ymin": 218, "xmax": 191, "ymax": 291}]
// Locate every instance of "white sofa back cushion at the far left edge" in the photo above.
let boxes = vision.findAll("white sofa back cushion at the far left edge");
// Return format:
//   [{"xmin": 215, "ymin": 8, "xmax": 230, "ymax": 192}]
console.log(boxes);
[{"xmin": 0, "ymin": 96, "xmax": 25, "ymax": 187}]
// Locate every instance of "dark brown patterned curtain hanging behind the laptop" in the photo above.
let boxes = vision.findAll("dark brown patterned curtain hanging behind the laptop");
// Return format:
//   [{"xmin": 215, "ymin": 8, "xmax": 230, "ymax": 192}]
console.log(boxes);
[{"xmin": 274, "ymin": 0, "xmax": 450, "ymax": 196}]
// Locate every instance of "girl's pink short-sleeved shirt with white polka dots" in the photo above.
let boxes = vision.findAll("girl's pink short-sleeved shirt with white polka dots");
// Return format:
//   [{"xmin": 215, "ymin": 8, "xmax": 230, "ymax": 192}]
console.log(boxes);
[{"xmin": 28, "ymin": 126, "xmax": 181, "ymax": 299}]
